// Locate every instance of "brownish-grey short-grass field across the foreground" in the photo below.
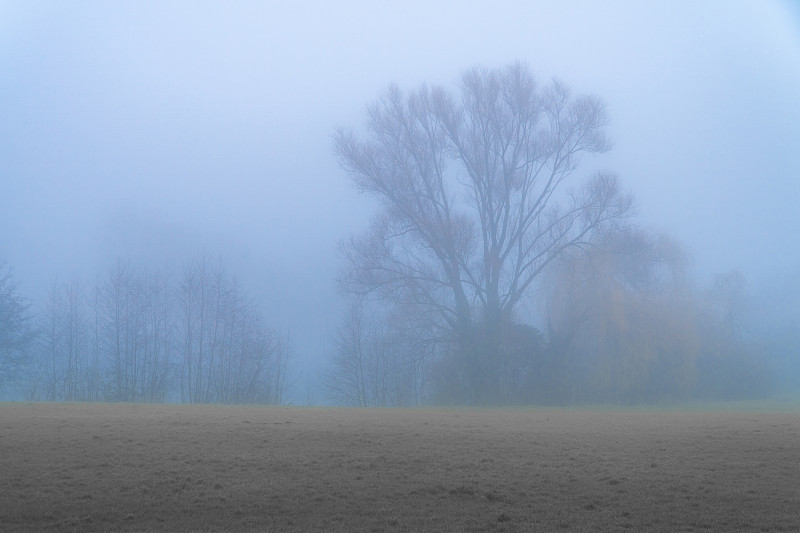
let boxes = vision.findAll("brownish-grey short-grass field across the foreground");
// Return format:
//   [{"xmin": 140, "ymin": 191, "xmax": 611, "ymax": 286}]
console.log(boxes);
[{"xmin": 0, "ymin": 403, "xmax": 800, "ymax": 531}]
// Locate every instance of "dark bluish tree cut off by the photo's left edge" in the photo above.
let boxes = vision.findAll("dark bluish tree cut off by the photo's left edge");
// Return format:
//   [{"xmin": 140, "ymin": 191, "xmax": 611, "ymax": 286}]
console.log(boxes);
[{"xmin": 0, "ymin": 260, "xmax": 35, "ymax": 391}]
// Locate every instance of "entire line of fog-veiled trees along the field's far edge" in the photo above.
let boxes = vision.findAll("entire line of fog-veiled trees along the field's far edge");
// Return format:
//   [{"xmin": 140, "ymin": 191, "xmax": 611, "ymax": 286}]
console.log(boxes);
[{"xmin": 0, "ymin": 63, "xmax": 800, "ymax": 406}]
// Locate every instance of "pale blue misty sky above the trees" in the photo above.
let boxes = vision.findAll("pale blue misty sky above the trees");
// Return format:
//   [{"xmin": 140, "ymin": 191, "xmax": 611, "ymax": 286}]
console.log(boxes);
[{"xmin": 0, "ymin": 0, "xmax": 800, "ymax": 394}]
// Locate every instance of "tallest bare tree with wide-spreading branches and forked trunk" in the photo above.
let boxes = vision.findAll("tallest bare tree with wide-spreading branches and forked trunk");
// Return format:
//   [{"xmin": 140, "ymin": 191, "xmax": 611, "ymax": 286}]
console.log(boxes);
[{"xmin": 335, "ymin": 64, "xmax": 631, "ymax": 401}]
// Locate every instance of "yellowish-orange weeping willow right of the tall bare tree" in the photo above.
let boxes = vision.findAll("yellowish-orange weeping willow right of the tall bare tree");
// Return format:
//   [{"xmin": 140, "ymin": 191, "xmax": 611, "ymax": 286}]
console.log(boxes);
[{"xmin": 543, "ymin": 228, "xmax": 702, "ymax": 402}]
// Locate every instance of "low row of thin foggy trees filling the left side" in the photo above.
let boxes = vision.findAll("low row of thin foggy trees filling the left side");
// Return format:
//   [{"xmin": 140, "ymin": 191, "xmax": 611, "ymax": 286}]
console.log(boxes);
[{"xmin": 0, "ymin": 255, "xmax": 290, "ymax": 404}]
